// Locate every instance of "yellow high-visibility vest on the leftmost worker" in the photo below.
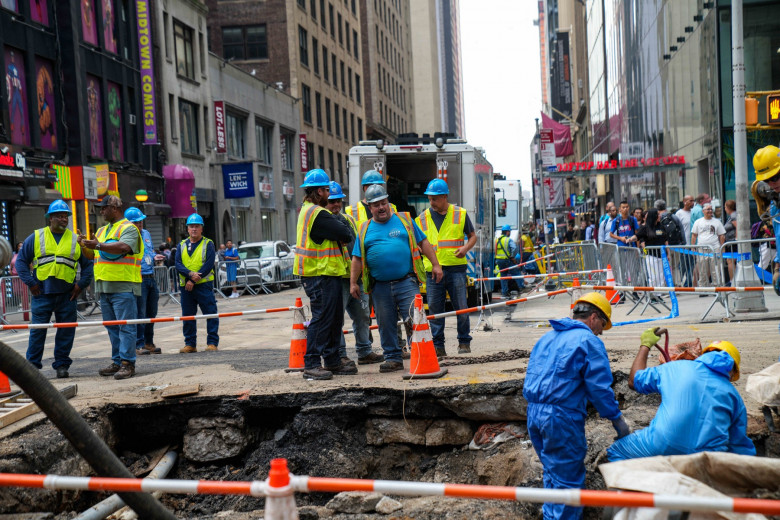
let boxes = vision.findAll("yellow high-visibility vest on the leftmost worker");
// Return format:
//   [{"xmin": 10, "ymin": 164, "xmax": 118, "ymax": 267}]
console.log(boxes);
[{"xmin": 33, "ymin": 227, "xmax": 81, "ymax": 283}]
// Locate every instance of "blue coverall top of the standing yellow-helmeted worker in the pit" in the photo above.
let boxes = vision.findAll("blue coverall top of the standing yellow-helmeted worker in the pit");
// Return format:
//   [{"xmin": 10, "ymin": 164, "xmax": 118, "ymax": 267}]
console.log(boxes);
[{"xmin": 523, "ymin": 318, "xmax": 621, "ymax": 421}]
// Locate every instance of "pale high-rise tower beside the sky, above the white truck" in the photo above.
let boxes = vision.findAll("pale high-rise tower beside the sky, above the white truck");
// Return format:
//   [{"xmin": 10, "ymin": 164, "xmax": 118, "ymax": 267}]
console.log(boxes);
[{"xmin": 409, "ymin": 0, "xmax": 466, "ymax": 138}]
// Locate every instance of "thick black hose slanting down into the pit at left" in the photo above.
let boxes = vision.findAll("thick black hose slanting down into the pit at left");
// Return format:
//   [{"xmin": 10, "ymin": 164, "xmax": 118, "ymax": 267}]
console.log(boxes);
[{"xmin": 0, "ymin": 341, "xmax": 176, "ymax": 520}]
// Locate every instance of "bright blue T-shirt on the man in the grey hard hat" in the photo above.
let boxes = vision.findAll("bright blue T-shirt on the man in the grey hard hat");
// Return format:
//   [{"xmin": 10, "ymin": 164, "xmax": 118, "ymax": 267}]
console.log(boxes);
[{"xmin": 352, "ymin": 213, "xmax": 426, "ymax": 282}]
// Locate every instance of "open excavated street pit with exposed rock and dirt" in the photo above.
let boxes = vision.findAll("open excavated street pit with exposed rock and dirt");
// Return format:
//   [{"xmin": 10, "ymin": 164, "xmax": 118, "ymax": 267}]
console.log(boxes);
[{"xmin": 0, "ymin": 372, "xmax": 778, "ymax": 520}]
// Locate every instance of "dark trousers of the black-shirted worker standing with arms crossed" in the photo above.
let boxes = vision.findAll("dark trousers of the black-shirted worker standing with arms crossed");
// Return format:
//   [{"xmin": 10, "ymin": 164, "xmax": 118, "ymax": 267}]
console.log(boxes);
[{"xmin": 301, "ymin": 276, "xmax": 344, "ymax": 370}]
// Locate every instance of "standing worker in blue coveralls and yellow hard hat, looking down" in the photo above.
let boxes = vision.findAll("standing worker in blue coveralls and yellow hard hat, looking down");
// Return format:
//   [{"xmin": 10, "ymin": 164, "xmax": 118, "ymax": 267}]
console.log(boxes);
[{"xmin": 523, "ymin": 292, "xmax": 630, "ymax": 519}]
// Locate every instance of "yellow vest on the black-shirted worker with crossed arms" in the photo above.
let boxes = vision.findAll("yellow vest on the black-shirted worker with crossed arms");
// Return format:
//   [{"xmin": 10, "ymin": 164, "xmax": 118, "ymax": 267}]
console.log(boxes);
[{"xmin": 293, "ymin": 202, "xmax": 349, "ymax": 277}]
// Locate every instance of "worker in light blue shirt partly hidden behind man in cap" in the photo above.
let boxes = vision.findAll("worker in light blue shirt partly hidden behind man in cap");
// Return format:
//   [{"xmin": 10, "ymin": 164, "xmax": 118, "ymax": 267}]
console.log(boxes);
[{"xmin": 125, "ymin": 208, "xmax": 162, "ymax": 356}]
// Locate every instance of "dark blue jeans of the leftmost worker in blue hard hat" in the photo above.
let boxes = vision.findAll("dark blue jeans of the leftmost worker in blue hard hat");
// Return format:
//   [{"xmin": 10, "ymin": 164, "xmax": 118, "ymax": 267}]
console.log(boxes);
[{"xmin": 24, "ymin": 287, "xmax": 76, "ymax": 369}]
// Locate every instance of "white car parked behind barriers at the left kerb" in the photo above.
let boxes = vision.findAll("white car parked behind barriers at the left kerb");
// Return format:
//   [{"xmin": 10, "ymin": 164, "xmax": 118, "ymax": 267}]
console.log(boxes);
[{"xmin": 218, "ymin": 240, "xmax": 300, "ymax": 291}]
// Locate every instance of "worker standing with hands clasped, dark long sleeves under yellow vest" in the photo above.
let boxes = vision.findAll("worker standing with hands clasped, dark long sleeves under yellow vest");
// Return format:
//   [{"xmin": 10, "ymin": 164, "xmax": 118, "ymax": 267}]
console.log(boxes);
[{"xmin": 176, "ymin": 213, "xmax": 219, "ymax": 354}]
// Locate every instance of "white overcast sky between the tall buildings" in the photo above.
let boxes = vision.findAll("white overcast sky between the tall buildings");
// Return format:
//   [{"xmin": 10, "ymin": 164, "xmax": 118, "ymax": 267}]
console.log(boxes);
[{"xmin": 460, "ymin": 0, "xmax": 542, "ymax": 191}]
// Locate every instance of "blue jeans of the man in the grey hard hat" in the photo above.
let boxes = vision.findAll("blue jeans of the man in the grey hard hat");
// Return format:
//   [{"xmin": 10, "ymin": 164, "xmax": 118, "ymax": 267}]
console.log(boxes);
[{"xmin": 371, "ymin": 276, "xmax": 420, "ymax": 363}]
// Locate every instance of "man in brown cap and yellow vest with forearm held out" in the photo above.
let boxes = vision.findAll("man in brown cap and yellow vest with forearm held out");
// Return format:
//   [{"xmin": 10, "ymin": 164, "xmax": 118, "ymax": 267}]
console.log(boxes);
[{"xmin": 81, "ymin": 195, "xmax": 144, "ymax": 379}]
